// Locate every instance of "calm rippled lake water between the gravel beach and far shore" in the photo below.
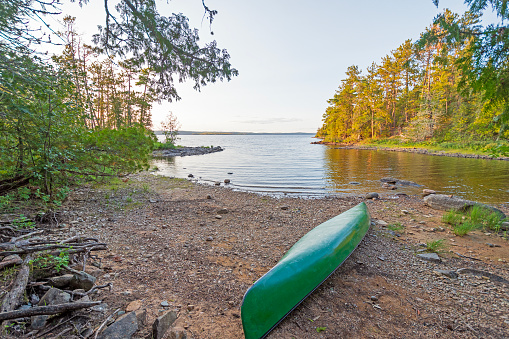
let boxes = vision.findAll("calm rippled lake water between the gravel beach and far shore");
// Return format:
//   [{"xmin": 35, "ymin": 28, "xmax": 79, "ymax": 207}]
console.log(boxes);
[{"xmin": 153, "ymin": 134, "xmax": 509, "ymax": 204}]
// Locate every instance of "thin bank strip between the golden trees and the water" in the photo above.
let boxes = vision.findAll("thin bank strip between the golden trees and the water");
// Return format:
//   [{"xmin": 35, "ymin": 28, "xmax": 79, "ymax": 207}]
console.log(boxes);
[{"xmin": 312, "ymin": 141, "xmax": 509, "ymax": 161}]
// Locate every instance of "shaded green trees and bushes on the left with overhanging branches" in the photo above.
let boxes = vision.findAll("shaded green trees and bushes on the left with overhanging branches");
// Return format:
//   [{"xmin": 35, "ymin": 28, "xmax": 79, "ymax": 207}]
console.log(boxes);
[{"xmin": 0, "ymin": 0, "xmax": 237, "ymax": 207}]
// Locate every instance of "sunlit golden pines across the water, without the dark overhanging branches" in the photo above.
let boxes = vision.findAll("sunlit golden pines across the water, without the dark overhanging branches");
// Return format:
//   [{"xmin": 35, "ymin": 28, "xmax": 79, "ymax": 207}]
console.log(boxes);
[{"xmin": 317, "ymin": 10, "xmax": 509, "ymax": 142}]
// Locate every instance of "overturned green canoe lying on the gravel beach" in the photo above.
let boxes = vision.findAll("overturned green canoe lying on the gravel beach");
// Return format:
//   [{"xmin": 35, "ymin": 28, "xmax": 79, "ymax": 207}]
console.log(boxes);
[{"xmin": 241, "ymin": 203, "xmax": 370, "ymax": 339}]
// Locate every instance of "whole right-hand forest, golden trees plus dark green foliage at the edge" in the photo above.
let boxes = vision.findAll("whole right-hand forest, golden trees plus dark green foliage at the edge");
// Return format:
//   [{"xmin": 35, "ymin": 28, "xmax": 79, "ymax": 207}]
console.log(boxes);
[{"xmin": 317, "ymin": 1, "xmax": 509, "ymax": 153}]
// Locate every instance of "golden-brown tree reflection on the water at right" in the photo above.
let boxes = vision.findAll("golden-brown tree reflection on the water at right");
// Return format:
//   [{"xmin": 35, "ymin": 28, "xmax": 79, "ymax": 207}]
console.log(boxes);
[{"xmin": 324, "ymin": 147, "xmax": 509, "ymax": 203}]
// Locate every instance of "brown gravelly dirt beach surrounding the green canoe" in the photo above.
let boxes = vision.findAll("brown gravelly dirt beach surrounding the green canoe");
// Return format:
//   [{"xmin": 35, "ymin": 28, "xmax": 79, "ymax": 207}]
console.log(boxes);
[{"xmin": 63, "ymin": 174, "xmax": 509, "ymax": 338}]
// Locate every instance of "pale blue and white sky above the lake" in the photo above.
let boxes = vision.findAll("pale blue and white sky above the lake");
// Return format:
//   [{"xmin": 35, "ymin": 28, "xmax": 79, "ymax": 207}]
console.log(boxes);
[{"xmin": 52, "ymin": 0, "xmax": 500, "ymax": 133}]
